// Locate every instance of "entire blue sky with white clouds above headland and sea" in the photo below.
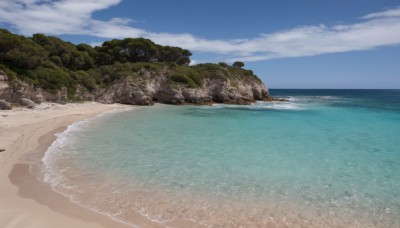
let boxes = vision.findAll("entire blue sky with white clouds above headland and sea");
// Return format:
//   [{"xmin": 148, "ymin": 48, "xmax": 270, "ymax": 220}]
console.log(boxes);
[{"xmin": 0, "ymin": 0, "xmax": 400, "ymax": 89}]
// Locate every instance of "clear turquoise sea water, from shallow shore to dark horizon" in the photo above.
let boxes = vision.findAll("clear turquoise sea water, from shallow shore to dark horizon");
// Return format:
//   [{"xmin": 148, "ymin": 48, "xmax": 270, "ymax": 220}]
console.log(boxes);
[{"xmin": 43, "ymin": 90, "xmax": 400, "ymax": 228}]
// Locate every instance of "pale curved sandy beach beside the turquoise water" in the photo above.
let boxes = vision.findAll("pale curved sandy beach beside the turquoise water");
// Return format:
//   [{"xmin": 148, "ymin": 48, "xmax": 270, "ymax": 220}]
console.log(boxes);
[{"xmin": 0, "ymin": 102, "xmax": 140, "ymax": 228}]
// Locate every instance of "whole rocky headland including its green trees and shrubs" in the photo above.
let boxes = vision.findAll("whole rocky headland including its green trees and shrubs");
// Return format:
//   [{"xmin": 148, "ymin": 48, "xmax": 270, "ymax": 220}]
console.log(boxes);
[{"xmin": 0, "ymin": 28, "xmax": 271, "ymax": 108}]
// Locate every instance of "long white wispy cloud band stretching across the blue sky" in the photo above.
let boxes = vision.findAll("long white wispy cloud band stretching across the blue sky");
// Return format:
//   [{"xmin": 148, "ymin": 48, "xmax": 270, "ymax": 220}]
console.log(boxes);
[{"xmin": 0, "ymin": 0, "xmax": 400, "ymax": 61}]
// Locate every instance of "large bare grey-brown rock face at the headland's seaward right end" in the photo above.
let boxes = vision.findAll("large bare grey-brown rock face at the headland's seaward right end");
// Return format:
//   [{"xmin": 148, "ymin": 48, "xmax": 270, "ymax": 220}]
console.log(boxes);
[{"xmin": 97, "ymin": 69, "xmax": 269, "ymax": 105}]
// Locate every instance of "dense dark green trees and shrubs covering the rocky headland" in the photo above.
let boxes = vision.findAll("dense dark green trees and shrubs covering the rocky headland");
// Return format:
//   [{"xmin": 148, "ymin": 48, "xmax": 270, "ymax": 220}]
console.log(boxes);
[{"xmin": 0, "ymin": 29, "xmax": 258, "ymax": 98}]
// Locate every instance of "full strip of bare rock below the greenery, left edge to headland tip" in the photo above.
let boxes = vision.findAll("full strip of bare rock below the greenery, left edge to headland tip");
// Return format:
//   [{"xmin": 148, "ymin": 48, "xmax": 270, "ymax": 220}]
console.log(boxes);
[{"xmin": 0, "ymin": 68, "xmax": 271, "ymax": 107}]
